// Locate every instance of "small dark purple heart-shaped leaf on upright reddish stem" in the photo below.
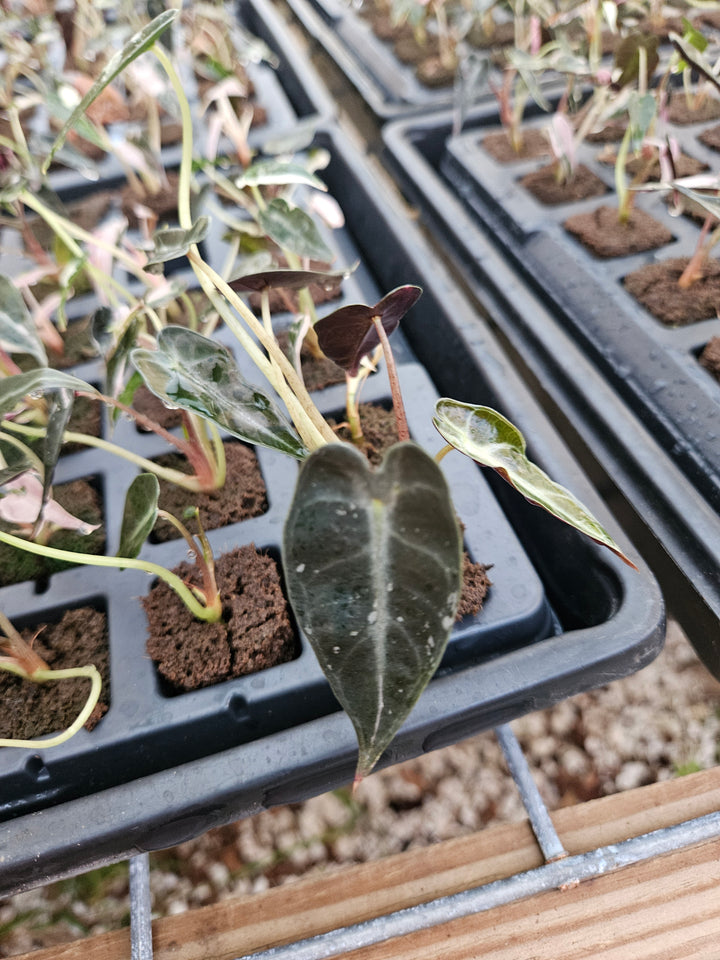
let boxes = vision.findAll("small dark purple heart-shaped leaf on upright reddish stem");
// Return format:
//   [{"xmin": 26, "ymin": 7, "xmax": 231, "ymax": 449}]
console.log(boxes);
[{"xmin": 313, "ymin": 284, "xmax": 422, "ymax": 377}]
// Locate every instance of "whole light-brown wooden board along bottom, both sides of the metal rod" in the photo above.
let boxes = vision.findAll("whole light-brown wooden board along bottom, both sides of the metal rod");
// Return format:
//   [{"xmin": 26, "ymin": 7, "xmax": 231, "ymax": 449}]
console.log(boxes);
[{"xmin": 12, "ymin": 768, "xmax": 720, "ymax": 960}]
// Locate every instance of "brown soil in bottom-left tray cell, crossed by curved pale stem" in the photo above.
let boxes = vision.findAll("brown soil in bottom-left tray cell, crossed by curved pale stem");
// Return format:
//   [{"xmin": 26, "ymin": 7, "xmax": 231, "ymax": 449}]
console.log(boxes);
[{"xmin": 0, "ymin": 607, "xmax": 110, "ymax": 740}]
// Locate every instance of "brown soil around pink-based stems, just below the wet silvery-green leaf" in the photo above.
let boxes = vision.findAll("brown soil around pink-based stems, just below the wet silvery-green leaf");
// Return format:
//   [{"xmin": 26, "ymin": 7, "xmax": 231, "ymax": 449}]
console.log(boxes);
[{"xmin": 151, "ymin": 441, "xmax": 268, "ymax": 543}]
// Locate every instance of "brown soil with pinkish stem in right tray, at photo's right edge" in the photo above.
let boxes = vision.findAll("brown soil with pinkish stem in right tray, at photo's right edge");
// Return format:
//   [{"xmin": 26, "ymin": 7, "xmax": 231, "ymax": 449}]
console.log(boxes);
[{"xmin": 624, "ymin": 257, "xmax": 720, "ymax": 326}]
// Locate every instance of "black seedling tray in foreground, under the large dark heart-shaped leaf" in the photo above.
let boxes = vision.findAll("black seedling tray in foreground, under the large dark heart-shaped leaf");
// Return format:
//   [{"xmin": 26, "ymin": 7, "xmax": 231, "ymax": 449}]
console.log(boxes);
[{"xmin": 0, "ymin": 125, "xmax": 664, "ymax": 895}]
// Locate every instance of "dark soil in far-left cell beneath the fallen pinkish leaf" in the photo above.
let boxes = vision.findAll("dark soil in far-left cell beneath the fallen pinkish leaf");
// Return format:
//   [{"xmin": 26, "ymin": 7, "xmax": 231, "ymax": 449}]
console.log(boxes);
[{"xmin": 0, "ymin": 480, "xmax": 105, "ymax": 586}]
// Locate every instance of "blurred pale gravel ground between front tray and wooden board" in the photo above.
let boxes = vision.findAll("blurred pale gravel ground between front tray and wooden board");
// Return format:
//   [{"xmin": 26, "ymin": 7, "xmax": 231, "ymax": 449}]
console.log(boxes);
[{"xmin": 0, "ymin": 621, "xmax": 720, "ymax": 957}]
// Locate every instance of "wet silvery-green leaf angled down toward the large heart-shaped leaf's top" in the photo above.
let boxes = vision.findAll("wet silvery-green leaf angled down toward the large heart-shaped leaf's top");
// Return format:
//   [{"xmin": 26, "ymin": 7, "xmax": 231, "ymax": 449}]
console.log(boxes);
[{"xmin": 130, "ymin": 326, "xmax": 308, "ymax": 460}]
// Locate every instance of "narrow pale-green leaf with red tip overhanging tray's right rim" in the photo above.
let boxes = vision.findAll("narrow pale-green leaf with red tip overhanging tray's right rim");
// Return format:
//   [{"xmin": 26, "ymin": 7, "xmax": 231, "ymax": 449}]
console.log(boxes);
[{"xmin": 433, "ymin": 397, "xmax": 635, "ymax": 567}]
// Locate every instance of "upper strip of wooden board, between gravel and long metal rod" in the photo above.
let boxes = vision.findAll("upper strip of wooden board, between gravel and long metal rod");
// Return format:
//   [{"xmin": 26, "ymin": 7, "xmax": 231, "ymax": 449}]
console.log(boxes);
[{"xmin": 12, "ymin": 767, "xmax": 720, "ymax": 960}]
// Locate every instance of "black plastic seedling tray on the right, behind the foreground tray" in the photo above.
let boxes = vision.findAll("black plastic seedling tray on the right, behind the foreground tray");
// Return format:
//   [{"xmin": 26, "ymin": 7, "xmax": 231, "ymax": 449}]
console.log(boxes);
[{"xmin": 384, "ymin": 110, "xmax": 720, "ymax": 660}]
